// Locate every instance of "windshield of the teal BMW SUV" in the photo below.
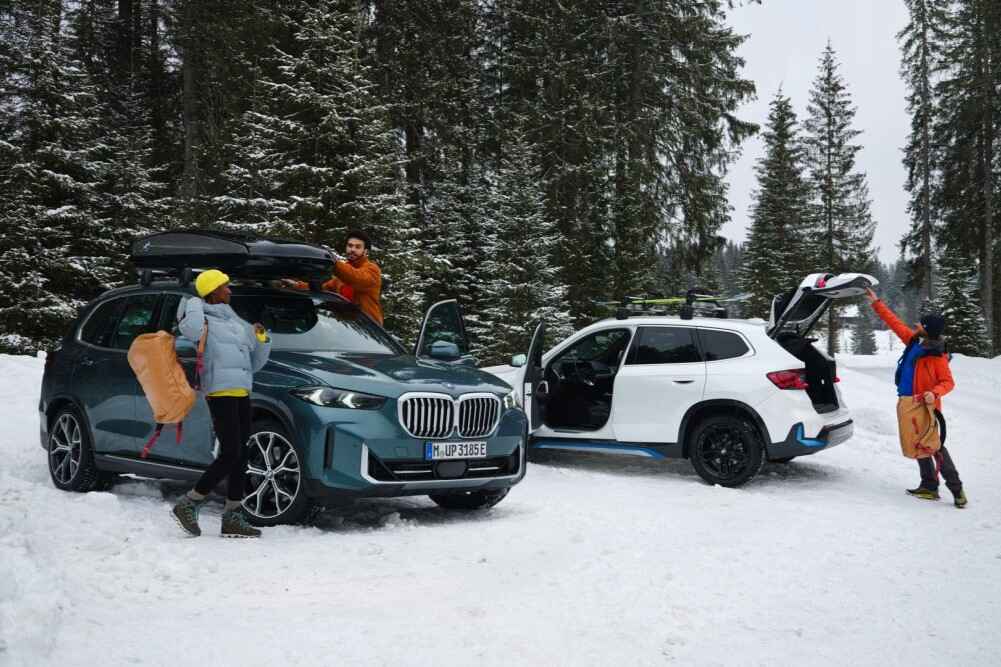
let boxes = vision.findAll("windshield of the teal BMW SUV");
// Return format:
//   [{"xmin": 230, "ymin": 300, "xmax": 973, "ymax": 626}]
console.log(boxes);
[{"xmin": 230, "ymin": 294, "xmax": 405, "ymax": 356}]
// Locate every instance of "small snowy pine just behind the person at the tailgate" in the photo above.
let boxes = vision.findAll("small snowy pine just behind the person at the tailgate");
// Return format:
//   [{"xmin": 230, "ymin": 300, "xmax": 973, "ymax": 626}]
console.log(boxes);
[{"xmin": 937, "ymin": 248, "xmax": 990, "ymax": 357}]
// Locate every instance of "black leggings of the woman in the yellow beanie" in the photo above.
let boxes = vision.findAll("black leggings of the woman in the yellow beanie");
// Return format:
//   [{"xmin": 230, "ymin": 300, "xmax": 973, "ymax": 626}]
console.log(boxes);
[{"xmin": 194, "ymin": 396, "xmax": 250, "ymax": 501}]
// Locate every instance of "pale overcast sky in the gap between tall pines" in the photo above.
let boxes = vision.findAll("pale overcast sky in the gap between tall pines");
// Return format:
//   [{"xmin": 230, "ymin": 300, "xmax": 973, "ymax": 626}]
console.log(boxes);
[{"xmin": 722, "ymin": 0, "xmax": 910, "ymax": 268}]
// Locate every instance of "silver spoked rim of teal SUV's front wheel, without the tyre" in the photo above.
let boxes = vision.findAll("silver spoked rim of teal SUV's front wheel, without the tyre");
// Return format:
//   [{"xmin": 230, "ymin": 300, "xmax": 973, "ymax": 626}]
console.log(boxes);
[{"xmin": 243, "ymin": 431, "xmax": 302, "ymax": 519}]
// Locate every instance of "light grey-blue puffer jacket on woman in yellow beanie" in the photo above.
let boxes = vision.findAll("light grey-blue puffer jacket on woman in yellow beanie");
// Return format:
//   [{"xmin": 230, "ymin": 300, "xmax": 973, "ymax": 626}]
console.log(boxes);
[{"xmin": 177, "ymin": 297, "xmax": 271, "ymax": 394}]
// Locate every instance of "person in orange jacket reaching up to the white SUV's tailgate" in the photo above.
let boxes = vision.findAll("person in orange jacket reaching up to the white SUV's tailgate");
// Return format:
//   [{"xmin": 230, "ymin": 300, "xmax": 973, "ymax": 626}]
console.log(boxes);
[{"xmin": 868, "ymin": 289, "xmax": 966, "ymax": 508}]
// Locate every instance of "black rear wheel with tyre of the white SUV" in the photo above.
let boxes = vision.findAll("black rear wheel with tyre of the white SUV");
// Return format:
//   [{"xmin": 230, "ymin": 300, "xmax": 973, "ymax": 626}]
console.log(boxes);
[{"xmin": 689, "ymin": 415, "xmax": 765, "ymax": 487}]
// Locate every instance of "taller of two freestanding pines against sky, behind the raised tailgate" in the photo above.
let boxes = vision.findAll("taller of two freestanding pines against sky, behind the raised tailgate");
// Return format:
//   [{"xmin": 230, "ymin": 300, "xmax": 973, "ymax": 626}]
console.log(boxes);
[{"xmin": 804, "ymin": 43, "xmax": 875, "ymax": 355}]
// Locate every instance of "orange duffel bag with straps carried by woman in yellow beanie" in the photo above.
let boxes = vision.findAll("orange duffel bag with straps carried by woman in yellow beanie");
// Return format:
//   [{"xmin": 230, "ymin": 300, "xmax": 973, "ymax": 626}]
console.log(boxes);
[{"xmin": 128, "ymin": 326, "xmax": 208, "ymax": 459}]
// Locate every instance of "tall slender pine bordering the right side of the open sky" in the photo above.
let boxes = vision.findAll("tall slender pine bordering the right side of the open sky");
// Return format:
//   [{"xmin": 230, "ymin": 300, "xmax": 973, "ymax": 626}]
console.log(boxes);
[{"xmin": 897, "ymin": 0, "xmax": 950, "ymax": 296}]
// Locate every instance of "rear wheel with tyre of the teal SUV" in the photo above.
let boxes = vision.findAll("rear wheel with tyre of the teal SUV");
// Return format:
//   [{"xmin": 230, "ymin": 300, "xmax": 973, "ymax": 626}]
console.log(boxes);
[{"xmin": 46, "ymin": 406, "xmax": 103, "ymax": 493}]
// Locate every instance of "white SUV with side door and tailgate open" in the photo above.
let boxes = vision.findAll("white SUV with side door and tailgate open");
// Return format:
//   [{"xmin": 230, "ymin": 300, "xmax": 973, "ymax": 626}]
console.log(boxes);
[{"xmin": 485, "ymin": 273, "xmax": 877, "ymax": 487}]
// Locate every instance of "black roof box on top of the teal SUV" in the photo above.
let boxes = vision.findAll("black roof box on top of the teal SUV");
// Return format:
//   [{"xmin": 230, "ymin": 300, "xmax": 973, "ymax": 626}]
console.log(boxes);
[{"xmin": 132, "ymin": 230, "xmax": 333, "ymax": 279}]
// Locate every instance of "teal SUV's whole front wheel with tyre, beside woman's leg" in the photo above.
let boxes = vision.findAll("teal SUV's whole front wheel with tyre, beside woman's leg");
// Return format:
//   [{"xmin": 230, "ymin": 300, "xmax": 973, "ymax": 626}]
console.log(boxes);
[{"xmin": 243, "ymin": 420, "xmax": 315, "ymax": 526}]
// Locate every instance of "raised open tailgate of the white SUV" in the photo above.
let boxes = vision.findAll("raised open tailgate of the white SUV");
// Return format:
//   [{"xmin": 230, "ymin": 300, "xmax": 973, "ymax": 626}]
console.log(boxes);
[{"xmin": 768, "ymin": 273, "xmax": 879, "ymax": 339}]
